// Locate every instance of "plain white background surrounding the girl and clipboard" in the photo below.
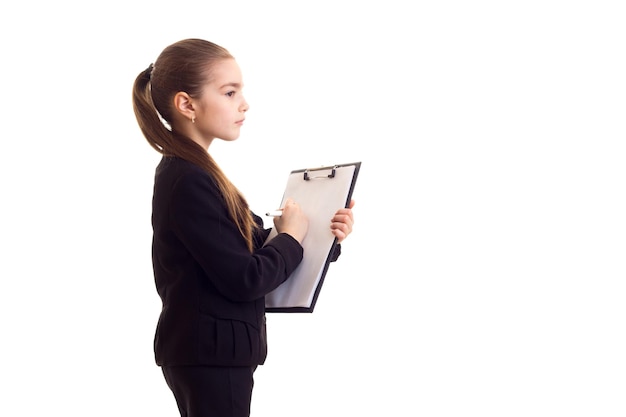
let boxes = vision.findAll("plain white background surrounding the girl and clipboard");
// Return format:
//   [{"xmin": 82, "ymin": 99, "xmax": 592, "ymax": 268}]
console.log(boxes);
[{"xmin": 0, "ymin": 0, "xmax": 626, "ymax": 417}]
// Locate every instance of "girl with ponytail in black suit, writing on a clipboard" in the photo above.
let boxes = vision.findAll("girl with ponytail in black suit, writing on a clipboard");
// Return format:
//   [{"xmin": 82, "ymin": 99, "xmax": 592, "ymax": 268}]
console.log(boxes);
[{"xmin": 133, "ymin": 39, "xmax": 354, "ymax": 417}]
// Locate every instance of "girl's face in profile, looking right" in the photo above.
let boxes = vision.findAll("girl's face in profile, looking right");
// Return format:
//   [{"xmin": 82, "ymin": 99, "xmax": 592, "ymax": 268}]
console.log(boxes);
[{"xmin": 194, "ymin": 59, "xmax": 249, "ymax": 147}]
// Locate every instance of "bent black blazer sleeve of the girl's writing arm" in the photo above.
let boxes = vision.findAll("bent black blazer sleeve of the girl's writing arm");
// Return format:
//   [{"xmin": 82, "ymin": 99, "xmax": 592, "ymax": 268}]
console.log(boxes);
[{"xmin": 169, "ymin": 169, "xmax": 303, "ymax": 301}]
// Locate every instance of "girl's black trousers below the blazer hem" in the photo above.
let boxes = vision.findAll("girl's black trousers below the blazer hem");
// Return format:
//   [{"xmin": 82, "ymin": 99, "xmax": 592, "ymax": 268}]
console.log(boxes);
[{"xmin": 161, "ymin": 366, "xmax": 256, "ymax": 417}]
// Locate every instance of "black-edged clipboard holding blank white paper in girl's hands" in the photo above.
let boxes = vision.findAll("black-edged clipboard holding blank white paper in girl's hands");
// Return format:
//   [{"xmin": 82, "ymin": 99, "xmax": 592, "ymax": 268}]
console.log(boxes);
[{"xmin": 265, "ymin": 162, "xmax": 361, "ymax": 313}]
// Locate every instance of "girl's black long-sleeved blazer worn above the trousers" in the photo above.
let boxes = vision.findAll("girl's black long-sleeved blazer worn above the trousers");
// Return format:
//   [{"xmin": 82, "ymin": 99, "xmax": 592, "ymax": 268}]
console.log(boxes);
[{"xmin": 152, "ymin": 157, "xmax": 303, "ymax": 366}]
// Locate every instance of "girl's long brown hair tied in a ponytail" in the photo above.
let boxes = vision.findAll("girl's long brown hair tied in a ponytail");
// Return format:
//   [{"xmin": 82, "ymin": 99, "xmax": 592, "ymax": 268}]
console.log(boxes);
[{"xmin": 133, "ymin": 39, "xmax": 258, "ymax": 252}]
